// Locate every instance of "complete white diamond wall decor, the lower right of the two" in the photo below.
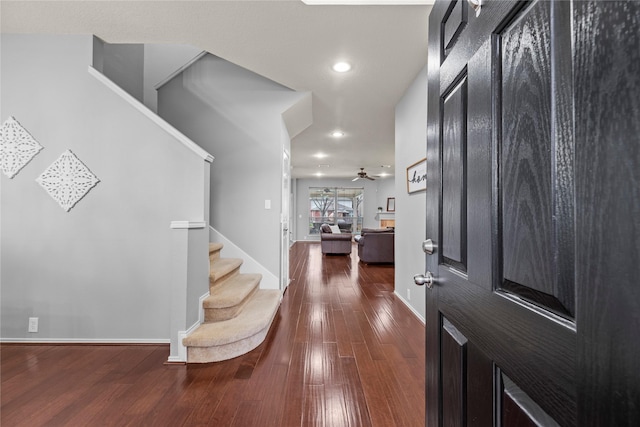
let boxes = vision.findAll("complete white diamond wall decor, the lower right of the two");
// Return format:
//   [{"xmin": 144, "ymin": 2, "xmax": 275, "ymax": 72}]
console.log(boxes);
[{"xmin": 36, "ymin": 150, "xmax": 100, "ymax": 212}]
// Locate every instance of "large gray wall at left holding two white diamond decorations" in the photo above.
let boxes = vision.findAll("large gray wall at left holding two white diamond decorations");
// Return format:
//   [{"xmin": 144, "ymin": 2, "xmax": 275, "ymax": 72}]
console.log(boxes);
[{"xmin": 0, "ymin": 34, "xmax": 207, "ymax": 342}]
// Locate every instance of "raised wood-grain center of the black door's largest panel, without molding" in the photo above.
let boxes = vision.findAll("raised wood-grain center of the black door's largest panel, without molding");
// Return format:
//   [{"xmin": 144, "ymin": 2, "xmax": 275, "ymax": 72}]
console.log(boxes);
[{"xmin": 498, "ymin": 2, "xmax": 554, "ymax": 310}]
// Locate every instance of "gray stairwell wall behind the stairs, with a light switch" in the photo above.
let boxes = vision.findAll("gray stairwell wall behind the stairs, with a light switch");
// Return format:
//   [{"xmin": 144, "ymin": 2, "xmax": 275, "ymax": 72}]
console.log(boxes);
[{"xmin": 158, "ymin": 55, "xmax": 303, "ymax": 276}]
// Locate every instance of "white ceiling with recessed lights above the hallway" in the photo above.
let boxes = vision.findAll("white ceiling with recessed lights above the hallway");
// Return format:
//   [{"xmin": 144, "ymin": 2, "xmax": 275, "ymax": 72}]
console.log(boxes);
[{"xmin": 0, "ymin": 0, "xmax": 431, "ymax": 181}]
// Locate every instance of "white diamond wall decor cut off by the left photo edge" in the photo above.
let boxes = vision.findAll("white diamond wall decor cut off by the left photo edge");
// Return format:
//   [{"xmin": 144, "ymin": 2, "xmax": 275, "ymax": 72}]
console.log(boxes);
[{"xmin": 0, "ymin": 116, "xmax": 43, "ymax": 178}]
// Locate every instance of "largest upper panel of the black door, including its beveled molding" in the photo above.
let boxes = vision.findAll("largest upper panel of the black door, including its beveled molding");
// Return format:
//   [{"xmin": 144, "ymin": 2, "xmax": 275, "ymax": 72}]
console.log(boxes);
[{"xmin": 494, "ymin": 2, "xmax": 575, "ymax": 318}]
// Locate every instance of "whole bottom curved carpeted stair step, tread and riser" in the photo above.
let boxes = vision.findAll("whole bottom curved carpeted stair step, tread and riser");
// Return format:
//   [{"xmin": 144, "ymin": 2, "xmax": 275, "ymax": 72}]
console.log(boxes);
[{"xmin": 182, "ymin": 289, "xmax": 282, "ymax": 363}]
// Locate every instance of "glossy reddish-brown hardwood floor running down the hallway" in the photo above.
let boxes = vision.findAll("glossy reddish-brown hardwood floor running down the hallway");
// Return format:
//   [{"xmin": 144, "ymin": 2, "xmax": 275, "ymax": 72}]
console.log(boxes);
[{"xmin": 0, "ymin": 243, "xmax": 425, "ymax": 427}]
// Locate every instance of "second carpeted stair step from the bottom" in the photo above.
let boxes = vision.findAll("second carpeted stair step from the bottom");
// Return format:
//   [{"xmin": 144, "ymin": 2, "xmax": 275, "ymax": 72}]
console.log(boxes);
[{"xmin": 202, "ymin": 274, "xmax": 262, "ymax": 322}]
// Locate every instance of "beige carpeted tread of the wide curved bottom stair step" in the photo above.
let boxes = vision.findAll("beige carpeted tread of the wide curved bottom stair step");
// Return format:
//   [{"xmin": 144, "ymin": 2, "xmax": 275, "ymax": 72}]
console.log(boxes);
[{"xmin": 182, "ymin": 289, "xmax": 281, "ymax": 350}]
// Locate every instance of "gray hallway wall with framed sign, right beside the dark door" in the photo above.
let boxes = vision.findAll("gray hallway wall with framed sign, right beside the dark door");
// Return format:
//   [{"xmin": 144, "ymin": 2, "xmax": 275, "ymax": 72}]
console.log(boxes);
[{"xmin": 395, "ymin": 67, "xmax": 428, "ymax": 321}]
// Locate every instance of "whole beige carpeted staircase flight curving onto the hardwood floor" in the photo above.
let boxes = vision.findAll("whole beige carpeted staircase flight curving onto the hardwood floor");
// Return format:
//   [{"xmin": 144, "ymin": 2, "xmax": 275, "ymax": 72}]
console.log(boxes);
[{"xmin": 182, "ymin": 243, "xmax": 281, "ymax": 363}]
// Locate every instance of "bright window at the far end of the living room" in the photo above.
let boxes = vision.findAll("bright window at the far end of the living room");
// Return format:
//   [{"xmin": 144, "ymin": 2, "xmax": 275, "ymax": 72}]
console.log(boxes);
[{"xmin": 309, "ymin": 187, "xmax": 364, "ymax": 234}]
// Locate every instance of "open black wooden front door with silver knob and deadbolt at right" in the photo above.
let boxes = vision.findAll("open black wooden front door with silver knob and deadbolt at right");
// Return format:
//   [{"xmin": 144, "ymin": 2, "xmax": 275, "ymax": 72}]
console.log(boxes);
[{"xmin": 426, "ymin": 0, "xmax": 640, "ymax": 427}]
